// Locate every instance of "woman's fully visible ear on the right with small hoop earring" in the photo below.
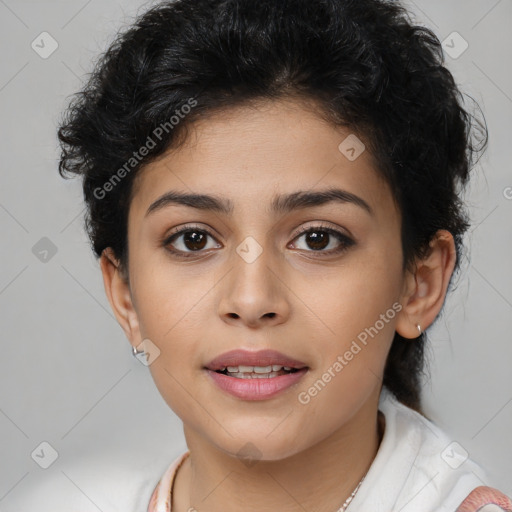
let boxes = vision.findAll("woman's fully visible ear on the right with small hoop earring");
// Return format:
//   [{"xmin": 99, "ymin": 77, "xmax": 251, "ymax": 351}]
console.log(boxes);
[{"xmin": 395, "ymin": 229, "xmax": 457, "ymax": 339}]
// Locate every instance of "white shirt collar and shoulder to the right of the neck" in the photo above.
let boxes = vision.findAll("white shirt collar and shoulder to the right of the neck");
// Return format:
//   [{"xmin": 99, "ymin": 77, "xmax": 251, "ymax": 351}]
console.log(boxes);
[{"xmin": 349, "ymin": 388, "xmax": 489, "ymax": 512}]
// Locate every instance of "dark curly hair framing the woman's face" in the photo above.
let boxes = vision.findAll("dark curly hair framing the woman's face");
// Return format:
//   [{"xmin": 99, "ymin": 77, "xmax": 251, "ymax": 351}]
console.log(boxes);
[{"xmin": 58, "ymin": 0, "xmax": 487, "ymax": 412}]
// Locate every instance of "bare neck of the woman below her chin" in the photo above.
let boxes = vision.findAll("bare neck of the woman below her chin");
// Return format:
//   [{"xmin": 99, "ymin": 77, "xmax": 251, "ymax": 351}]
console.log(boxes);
[{"xmin": 172, "ymin": 397, "xmax": 383, "ymax": 512}]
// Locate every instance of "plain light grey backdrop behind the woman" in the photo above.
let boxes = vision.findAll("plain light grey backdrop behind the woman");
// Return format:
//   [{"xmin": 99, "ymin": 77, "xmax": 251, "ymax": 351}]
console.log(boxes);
[{"xmin": 0, "ymin": 0, "xmax": 512, "ymax": 512}]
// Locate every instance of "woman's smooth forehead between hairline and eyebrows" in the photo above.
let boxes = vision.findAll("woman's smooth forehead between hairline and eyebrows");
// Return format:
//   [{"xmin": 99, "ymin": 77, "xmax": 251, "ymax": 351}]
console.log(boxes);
[{"xmin": 131, "ymin": 101, "xmax": 392, "ymax": 221}]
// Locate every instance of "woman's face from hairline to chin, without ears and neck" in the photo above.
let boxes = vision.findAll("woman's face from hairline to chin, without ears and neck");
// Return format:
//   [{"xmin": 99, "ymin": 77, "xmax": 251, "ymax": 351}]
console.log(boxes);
[{"xmin": 118, "ymin": 101, "xmax": 410, "ymax": 460}]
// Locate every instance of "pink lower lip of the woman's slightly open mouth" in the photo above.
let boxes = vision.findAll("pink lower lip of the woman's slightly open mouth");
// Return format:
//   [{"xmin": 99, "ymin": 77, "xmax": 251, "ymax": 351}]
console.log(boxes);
[{"xmin": 206, "ymin": 368, "xmax": 308, "ymax": 400}]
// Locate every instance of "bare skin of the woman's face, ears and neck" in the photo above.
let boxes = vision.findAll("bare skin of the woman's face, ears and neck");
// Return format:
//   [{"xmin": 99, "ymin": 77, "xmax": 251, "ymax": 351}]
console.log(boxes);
[{"xmin": 100, "ymin": 100, "xmax": 455, "ymax": 512}]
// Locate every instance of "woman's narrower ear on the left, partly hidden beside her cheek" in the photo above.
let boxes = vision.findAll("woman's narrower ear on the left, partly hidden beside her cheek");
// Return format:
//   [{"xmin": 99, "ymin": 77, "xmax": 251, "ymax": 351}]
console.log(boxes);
[{"xmin": 100, "ymin": 247, "xmax": 142, "ymax": 347}]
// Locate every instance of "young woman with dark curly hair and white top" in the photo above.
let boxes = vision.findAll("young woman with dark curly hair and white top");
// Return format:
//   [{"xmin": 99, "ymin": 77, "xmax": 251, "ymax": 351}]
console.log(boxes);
[{"xmin": 59, "ymin": 0, "xmax": 512, "ymax": 512}]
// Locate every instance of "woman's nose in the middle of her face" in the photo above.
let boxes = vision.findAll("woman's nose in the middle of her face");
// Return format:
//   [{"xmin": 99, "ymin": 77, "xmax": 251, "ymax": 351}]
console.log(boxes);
[{"xmin": 219, "ymin": 247, "xmax": 290, "ymax": 328}]
